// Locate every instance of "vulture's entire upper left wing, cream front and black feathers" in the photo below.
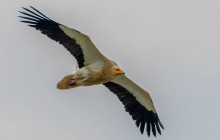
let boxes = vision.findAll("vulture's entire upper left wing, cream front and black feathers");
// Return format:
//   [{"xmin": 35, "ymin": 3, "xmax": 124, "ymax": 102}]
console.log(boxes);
[{"xmin": 19, "ymin": 6, "xmax": 105, "ymax": 68}]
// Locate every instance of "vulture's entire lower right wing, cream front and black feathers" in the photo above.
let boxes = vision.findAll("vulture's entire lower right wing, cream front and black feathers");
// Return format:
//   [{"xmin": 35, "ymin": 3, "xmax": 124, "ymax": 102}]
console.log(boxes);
[{"xmin": 104, "ymin": 75, "xmax": 164, "ymax": 136}]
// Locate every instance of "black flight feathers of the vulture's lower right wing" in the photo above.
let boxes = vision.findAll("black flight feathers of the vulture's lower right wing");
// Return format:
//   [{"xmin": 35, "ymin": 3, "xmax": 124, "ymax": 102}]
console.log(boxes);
[{"xmin": 104, "ymin": 82, "xmax": 164, "ymax": 137}]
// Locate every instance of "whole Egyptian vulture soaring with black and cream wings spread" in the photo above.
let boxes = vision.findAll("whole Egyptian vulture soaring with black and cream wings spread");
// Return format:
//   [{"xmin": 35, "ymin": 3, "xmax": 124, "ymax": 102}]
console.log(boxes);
[{"xmin": 19, "ymin": 6, "xmax": 164, "ymax": 136}]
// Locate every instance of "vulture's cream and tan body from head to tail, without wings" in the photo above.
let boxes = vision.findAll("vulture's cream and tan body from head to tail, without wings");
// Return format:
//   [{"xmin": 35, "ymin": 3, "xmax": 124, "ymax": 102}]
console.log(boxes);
[{"xmin": 57, "ymin": 59, "xmax": 123, "ymax": 89}]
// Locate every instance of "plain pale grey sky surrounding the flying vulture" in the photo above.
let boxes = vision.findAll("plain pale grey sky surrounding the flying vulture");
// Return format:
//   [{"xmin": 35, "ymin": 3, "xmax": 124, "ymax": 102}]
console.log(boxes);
[{"xmin": 0, "ymin": 0, "xmax": 220, "ymax": 140}]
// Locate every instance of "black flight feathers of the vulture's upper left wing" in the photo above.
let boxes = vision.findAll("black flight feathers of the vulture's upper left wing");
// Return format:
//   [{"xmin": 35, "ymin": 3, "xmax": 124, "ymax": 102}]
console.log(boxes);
[{"xmin": 19, "ymin": 6, "xmax": 85, "ymax": 68}]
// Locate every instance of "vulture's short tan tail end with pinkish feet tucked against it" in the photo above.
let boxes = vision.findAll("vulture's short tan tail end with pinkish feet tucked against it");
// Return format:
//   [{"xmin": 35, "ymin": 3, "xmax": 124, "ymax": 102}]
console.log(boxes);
[{"xmin": 57, "ymin": 74, "xmax": 78, "ymax": 90}]
